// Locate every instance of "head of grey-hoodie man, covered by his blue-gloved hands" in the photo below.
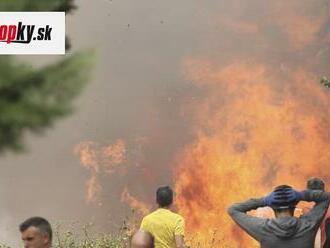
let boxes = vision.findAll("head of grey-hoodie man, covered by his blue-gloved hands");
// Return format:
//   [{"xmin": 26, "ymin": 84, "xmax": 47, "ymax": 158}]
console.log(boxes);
[{"xmin": 271, "ymin": 185, "xmax": 298, "ymax": 215}]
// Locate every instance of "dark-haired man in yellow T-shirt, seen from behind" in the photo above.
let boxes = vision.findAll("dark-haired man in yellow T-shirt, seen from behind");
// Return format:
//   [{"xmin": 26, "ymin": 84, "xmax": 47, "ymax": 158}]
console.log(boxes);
[{"xmin": 140, "ymin": 186, "xmax": 184, "ymax": 248}]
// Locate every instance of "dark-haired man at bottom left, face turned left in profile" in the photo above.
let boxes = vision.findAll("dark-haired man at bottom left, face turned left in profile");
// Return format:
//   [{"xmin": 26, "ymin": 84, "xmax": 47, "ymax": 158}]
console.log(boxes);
[{"xmin": 19, "ymin": 217, "xmax": 52, "ymax": 248}]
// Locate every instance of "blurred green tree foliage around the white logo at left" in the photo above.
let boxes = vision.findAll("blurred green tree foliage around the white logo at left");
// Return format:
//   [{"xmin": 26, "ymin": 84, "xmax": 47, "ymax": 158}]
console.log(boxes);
[{"xmin": 0, "ymin": 0, "xmax": 93, "ymax": 152}]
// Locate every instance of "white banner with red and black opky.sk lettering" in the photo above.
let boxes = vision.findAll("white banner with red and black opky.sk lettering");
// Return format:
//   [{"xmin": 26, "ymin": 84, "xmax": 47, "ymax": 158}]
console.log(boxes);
[{"xmin": 0, "ymin": 12, "xmax": 65, "ymax": 54}]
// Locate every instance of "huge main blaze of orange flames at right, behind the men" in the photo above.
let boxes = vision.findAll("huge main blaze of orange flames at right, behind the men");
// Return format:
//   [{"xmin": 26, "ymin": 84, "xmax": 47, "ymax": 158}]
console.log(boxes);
[{"xmin": 176, "ymin": 60, "xmax": 330, "ymax": 247}]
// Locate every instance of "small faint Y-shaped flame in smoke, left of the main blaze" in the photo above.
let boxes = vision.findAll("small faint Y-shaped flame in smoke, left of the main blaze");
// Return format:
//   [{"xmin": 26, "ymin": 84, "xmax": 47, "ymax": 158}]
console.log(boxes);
[{"xmin": 74, "ymin": 139, "xmax": 126, "ymax": 205}]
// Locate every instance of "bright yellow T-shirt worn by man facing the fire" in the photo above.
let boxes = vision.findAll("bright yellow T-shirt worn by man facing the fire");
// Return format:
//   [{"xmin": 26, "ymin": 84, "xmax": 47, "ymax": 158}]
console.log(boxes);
[{"xmin": 140, "ymin": 208, "xmax": 184, "ymax": 248}]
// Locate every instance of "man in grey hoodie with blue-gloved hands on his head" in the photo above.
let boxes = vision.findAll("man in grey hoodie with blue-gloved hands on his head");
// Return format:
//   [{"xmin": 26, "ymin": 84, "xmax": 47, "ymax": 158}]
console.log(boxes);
[{"xmin": 228, "ymin": 181, "xmax": 330, "ymax": 248}]
